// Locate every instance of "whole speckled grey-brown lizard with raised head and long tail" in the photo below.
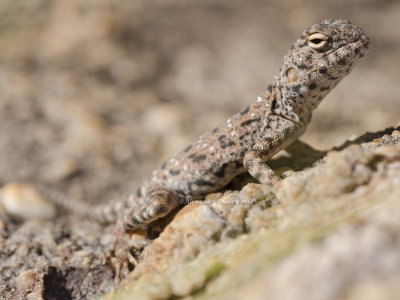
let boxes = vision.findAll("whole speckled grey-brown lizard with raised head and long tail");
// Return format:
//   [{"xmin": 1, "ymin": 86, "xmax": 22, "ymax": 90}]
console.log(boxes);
[{"xmin": 41, "ymin": 19, "xmax": 369, "ymax": 232}]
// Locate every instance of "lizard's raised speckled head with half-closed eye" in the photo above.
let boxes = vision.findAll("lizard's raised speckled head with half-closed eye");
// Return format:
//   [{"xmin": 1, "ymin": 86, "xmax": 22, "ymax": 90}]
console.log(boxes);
[{"xmin": 277, "ymin": 19, "xmax": 369, "ymax": 119}]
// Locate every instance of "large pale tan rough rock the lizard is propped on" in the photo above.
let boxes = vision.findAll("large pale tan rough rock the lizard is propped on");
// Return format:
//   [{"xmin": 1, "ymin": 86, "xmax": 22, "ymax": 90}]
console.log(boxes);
[{"xmin": 106, "ymin": 129, "xmax": 400, "ymax": 299}]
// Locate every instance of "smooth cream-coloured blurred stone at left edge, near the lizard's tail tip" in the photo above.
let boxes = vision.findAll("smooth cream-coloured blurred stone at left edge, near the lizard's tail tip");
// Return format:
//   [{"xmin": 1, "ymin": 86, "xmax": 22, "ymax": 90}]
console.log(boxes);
[{"xmin": 0, "ymin": 183, "xmax": 56, "ymax": 220}]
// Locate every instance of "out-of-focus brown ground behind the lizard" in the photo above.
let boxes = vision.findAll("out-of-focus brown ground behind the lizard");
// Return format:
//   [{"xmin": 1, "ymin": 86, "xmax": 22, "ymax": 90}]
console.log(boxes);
[{"xmin": 0, "ymin": 0, "xmax": 400, "ymax": 201}]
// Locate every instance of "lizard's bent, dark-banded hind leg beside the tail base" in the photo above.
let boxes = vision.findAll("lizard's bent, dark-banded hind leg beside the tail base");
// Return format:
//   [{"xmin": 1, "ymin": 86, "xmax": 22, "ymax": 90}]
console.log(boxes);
[{"xmin": 123, "ymin": 187, "xmax": 179, "ymax": 232}]
